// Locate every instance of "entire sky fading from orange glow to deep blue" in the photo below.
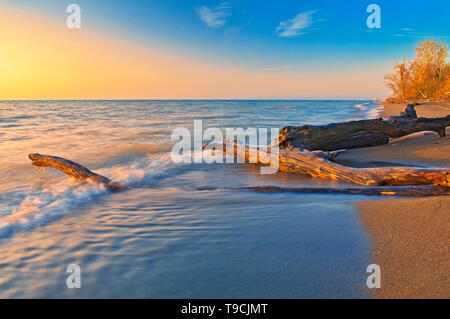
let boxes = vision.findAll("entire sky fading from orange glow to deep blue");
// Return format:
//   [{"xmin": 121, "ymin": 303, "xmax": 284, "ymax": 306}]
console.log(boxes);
[{"xmin": 0, "ymin": 0, "xmax": 450, "ymax": 100}]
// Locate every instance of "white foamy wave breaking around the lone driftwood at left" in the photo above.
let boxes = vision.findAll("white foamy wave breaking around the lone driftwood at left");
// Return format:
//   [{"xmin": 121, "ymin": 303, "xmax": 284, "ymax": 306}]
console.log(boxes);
[{"xmin": 0, "ymin": 153, "xmax": 180, "ymax": 239}]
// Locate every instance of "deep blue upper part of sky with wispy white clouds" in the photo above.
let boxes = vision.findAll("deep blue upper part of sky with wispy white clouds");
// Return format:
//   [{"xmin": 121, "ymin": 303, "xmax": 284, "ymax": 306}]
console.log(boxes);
[{"xmin": 3, "ymin": 0, "xmax": 450, "ymax": 99}]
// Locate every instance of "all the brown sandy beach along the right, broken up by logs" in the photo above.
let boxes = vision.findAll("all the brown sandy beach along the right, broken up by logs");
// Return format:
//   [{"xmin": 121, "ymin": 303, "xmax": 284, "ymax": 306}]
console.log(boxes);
[{"xmin": 348, "ymin": 103, "xmax": 450, "ymax": 298}]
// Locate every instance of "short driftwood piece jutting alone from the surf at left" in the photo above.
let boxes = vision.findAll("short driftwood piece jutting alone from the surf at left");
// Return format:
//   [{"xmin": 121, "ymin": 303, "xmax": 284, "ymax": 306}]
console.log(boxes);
[{"xmin": 28, "ymin": 153, "xmax": 126, "ymax": 190}]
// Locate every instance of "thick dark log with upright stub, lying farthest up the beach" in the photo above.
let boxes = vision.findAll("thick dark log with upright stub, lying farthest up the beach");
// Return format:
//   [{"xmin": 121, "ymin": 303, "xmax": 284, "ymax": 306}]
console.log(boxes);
[{"xmin": 278, "ymin": 104, "xmax": 450, "ymax": 151}]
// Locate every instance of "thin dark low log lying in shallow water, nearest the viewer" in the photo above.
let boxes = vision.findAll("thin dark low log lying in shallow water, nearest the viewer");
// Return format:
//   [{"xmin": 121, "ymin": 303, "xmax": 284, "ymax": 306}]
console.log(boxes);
[{"xmin": 229, "ymin": 185, "xmax": 450, "ymax": 197}]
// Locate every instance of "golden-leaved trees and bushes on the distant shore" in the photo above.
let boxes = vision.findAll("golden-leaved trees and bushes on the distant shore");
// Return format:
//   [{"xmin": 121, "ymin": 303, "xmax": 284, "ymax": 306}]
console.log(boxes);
[{"xmin": 385, "ymin": 40, "xmax": 450, "ymax": 102}]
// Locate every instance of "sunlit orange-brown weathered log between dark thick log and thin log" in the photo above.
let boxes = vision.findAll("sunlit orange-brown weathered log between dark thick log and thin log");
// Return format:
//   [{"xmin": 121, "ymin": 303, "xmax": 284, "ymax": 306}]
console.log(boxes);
[{"xmin": 216, "ymin": 140, "xmax": 450, "ymax": 187}]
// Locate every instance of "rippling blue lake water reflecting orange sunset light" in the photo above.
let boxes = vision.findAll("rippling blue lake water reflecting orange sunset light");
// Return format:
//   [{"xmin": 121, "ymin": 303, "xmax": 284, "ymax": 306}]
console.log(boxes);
[{"xmin": 0, "ymin": 101, "xmax": 379, "ymax": 298}]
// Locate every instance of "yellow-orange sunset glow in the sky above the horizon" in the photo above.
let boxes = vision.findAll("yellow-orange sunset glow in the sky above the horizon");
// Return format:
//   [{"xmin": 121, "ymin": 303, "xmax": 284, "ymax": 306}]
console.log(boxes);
[{"xmin": 0, "ymin": 6, "xmax": 386, "ymax": 100}]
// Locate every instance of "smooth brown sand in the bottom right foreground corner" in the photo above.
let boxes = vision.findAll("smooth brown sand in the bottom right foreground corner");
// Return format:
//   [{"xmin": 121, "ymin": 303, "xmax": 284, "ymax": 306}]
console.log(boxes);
[{"xmin": 358, "ymin": 196, "xmax": 450, "ymax": 298}]
